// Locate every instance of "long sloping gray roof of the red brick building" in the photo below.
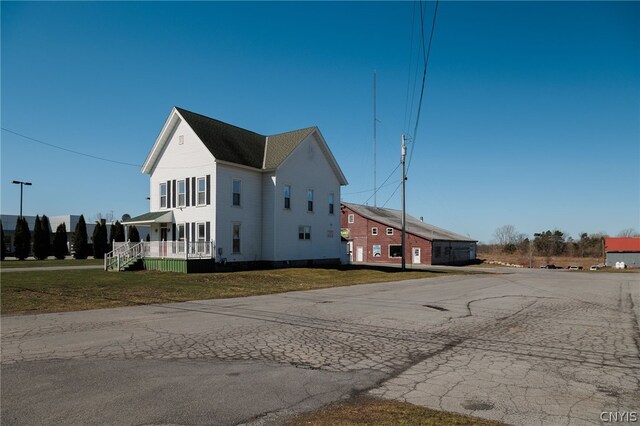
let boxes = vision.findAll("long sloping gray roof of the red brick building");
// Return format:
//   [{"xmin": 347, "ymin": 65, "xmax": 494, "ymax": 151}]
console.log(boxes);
[{"xmin": 342, "ymin": 203, "xmax": 477, "ymax": 242}]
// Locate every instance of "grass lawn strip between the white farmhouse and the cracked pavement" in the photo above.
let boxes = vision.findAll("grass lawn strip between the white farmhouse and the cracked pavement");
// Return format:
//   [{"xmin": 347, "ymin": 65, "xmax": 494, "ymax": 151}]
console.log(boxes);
[{"xmin": 0, "ymin": 262, "xmax": 476, "ymax": 314}]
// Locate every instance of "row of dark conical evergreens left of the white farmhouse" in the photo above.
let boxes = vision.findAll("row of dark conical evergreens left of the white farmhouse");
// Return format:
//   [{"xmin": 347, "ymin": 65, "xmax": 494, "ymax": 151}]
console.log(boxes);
[{"xmin": 0, "ymin": 215, "xmax": 140, "ymax": 260}]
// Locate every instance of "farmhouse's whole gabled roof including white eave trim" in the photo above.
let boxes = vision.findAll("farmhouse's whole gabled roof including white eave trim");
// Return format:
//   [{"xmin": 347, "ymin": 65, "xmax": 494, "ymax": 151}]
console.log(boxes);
[{"xmin": 142, "ymin": 107, "xmax": 347, "ymax": 185}]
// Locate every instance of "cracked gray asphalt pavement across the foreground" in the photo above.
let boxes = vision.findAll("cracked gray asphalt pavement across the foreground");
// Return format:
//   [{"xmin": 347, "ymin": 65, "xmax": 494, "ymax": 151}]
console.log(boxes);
[{"xmin": 1, "ymin": 270, "xmax": 640, "ymax": 425}]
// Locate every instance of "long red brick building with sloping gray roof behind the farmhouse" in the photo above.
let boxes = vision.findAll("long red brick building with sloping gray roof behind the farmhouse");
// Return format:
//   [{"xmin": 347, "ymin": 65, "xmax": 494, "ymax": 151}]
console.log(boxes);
[{"xmin": 340, "ymin": 203, "xmax": 477, "ymax": 265}]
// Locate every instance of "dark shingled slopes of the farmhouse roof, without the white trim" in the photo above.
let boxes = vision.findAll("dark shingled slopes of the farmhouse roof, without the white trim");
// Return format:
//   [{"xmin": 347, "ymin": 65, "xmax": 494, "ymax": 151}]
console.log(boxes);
[{"xmin": 176, "ymin": 107, "xmax": 316, "ymax": 169}]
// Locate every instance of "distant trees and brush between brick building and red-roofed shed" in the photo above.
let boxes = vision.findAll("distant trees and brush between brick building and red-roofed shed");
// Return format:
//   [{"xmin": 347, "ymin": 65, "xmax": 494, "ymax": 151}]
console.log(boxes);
[{"xmin": 478, "ymin": 225, "xmax": 640, "ymax": 257}]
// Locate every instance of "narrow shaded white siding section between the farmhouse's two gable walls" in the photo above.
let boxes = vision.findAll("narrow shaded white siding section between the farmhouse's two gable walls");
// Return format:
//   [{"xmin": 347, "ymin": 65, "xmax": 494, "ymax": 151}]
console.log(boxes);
[{"xmin": 216, "ymin": 163, "xmax": 262, "ymax": 262}]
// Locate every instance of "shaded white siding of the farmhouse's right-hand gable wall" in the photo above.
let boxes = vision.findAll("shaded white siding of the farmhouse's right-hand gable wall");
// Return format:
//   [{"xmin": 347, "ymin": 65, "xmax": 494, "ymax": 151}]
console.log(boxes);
[{"xmin": 268, "ymin": 133, "xmax": 341, "ymax": 261}]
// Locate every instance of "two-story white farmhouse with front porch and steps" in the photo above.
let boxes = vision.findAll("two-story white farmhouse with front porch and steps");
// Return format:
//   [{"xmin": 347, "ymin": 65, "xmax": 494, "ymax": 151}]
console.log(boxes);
[{"xmin": 115, "ymin": 107, "xmax": 347, "ymax": 271}]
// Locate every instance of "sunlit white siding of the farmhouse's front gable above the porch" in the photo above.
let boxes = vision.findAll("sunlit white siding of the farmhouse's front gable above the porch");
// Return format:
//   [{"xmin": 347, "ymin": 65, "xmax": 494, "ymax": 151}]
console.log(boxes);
[{"xmin": 149, "ymin": 121, "xmax": 216, "ymax": 245}]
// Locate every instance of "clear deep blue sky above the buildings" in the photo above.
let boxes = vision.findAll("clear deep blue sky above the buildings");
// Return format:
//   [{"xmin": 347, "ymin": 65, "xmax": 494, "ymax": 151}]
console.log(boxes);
[{"xmin": 0, "ymin": 1, "xmax": 640, "ymax": 242}]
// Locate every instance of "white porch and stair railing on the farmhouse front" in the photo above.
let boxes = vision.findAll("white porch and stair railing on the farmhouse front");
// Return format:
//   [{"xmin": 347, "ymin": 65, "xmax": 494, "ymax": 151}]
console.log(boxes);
[{"xmin": 104, "ymin": 241, "xmax": 215, "ymax": 271}]
